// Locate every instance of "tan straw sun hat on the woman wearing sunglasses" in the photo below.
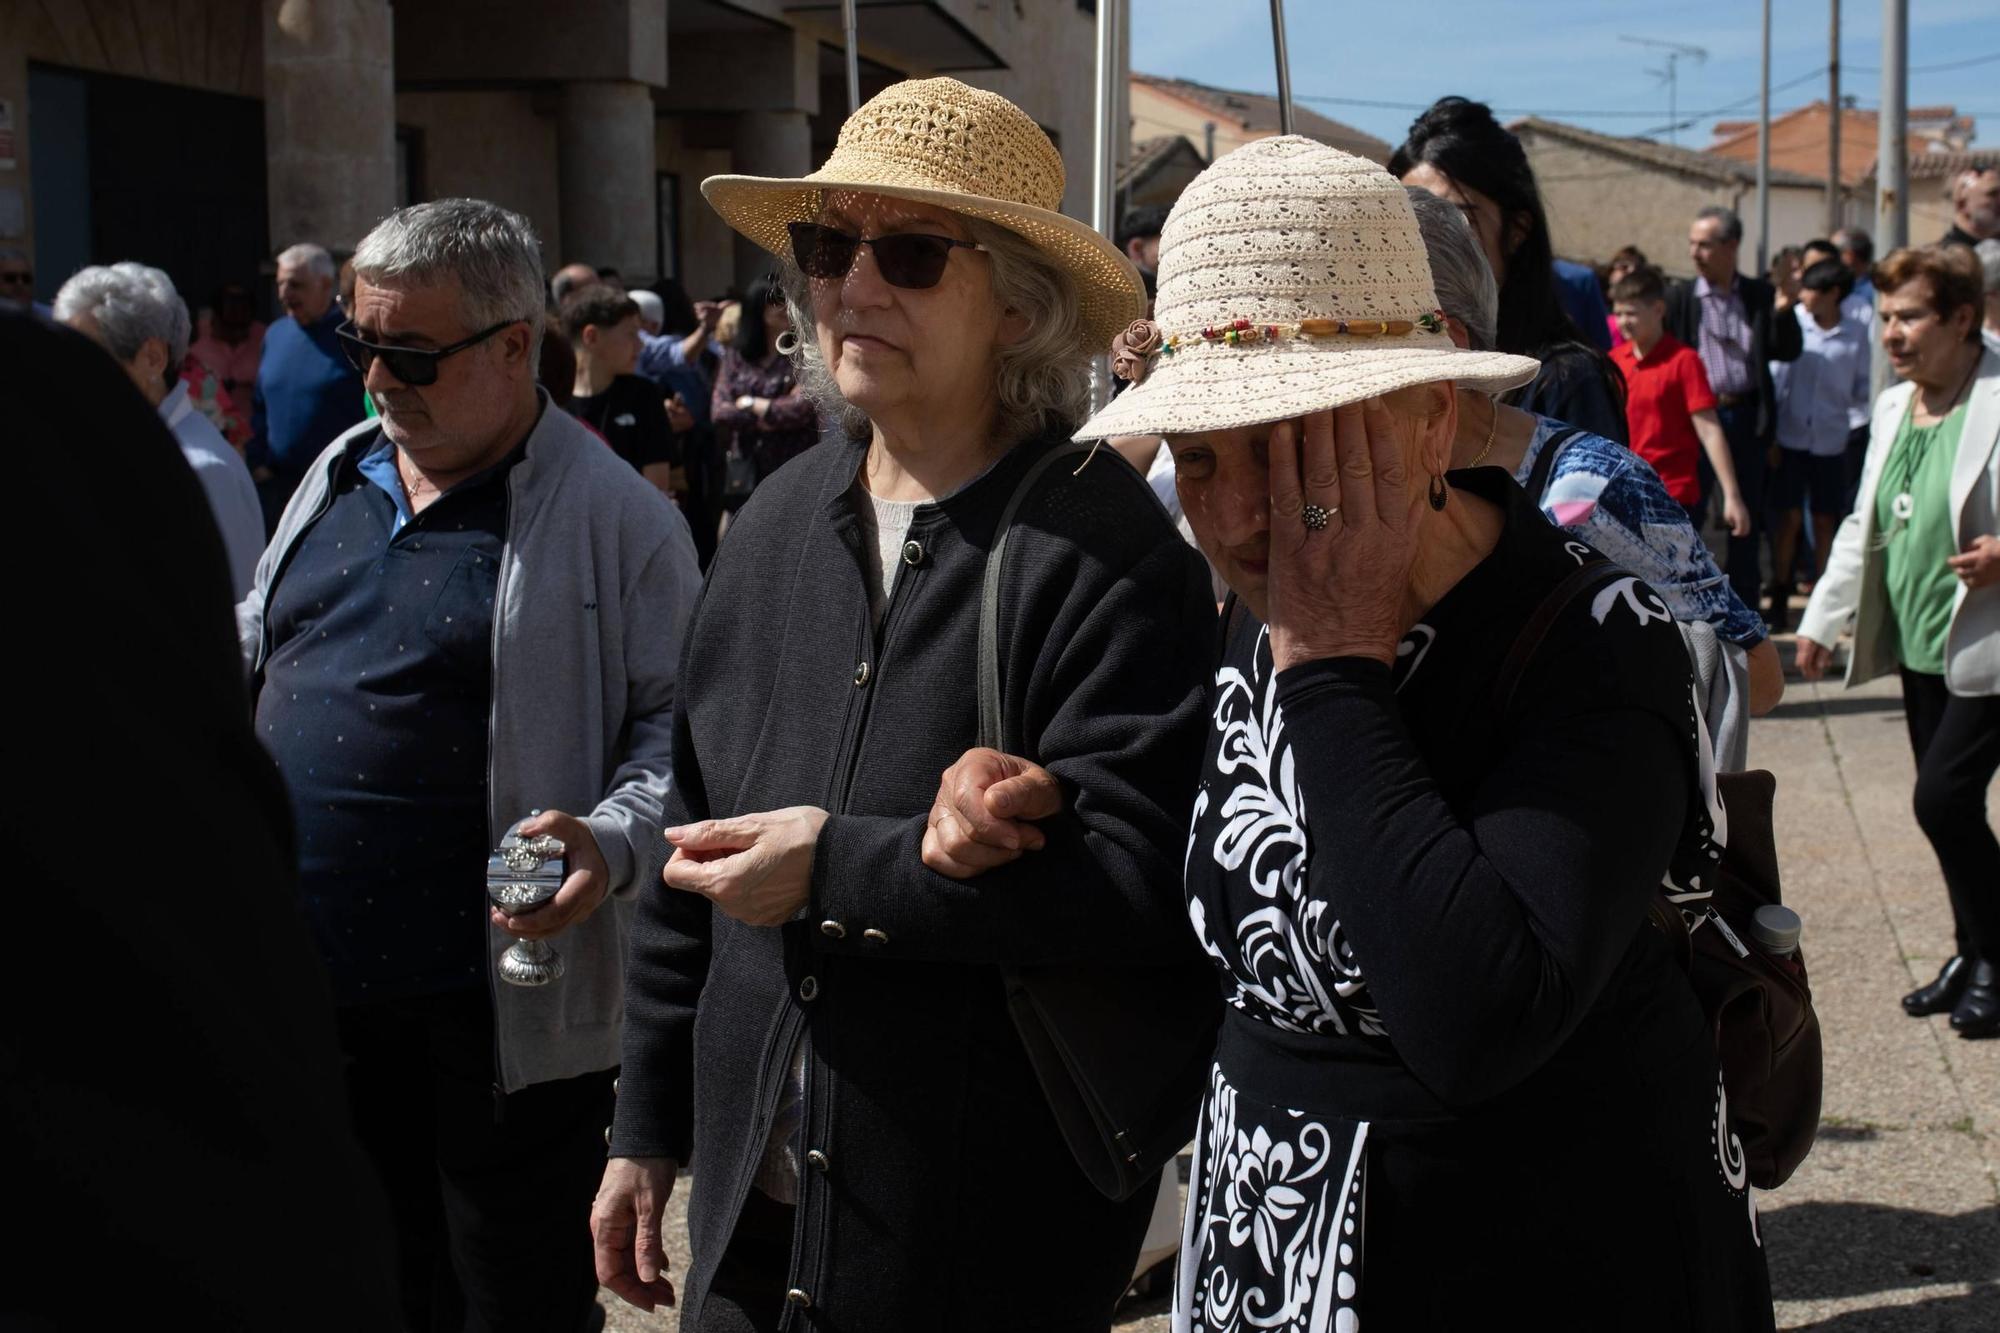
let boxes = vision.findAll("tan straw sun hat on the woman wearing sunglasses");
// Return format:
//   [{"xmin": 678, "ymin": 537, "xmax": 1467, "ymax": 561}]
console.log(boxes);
[{"xmin": 702, "ymin": 78, "xmax": 1146, "ymax": 352}]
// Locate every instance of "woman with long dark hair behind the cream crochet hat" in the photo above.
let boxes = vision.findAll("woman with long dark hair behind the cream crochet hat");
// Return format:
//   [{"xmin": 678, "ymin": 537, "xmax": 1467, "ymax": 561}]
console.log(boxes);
[{"xmin": 1388, "ymin": 98, "xmax": 1626, "ymax": 444}]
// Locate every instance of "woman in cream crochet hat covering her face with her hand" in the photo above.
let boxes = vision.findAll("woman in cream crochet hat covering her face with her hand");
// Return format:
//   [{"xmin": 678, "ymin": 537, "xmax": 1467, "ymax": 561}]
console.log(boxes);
[{"xmin": 940, "ymin": 138, "xmax": 1772, "ymax": 1333}]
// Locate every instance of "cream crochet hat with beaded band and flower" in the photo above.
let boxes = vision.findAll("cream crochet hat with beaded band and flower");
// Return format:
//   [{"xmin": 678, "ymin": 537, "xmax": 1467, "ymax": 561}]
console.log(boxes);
[{"xmin": 1076, "ymin": 134, "xmax": 1540, "ymax": 440}]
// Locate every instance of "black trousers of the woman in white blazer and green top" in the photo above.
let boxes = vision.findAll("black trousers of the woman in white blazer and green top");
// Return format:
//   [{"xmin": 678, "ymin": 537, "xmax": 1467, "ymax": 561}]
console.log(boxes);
[{"xmin": 1902, "ymin": 669, "xmax": 2000, "ymax": 963}]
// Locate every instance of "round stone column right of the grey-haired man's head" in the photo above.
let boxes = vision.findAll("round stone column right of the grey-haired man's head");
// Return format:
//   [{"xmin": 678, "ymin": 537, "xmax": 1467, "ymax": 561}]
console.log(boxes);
[{"xmin": 560, "ymin": 82, "xmax": 660, "ymax": 284}]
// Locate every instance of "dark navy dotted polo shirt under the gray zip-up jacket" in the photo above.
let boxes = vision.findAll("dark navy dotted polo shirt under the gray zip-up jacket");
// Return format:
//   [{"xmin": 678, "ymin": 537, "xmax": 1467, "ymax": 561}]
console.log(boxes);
[{"xmin": 256, "ymin": 432, "xmax": 520, "ymax": 1005}]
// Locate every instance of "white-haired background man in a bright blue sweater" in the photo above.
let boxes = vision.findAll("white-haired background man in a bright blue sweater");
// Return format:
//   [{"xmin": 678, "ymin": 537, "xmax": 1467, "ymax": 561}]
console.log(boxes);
[{"xmin": 244, "ymin": 244, "xmax": 364, "ymax": 528}]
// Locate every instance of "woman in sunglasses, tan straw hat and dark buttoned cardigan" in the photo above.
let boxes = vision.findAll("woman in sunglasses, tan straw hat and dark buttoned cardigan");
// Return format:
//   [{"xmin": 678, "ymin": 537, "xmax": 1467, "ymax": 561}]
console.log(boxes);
[{"xmin": 592, "ymin": 78, "xmax": 1214, "ymax": 1333}]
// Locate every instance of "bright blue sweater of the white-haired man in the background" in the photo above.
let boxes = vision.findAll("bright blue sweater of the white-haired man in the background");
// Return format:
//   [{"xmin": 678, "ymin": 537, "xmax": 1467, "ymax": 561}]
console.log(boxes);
[{"xmin": 246, "ymin": 304, "xmax": 366, "ymax": 480}]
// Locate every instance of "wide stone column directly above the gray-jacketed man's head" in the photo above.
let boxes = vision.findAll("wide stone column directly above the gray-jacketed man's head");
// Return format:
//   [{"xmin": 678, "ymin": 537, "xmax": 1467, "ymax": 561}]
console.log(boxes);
[{"xmin": 262, "ymin": 0, "xmax": 396, "ymax": 250}]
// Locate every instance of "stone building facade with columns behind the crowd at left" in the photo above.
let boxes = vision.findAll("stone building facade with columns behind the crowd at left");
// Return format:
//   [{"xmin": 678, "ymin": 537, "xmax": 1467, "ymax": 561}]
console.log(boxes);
[{"xmin": 0, "ymin": 0, "xmax": 1096, "ymax": 304}]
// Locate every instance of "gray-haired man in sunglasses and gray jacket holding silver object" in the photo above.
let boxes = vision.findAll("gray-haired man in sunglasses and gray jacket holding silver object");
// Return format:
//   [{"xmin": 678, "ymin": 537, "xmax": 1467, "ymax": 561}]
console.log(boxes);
[{"xmin": 238, "ymin": 200, "xmax": 700, "ymax": 1333}]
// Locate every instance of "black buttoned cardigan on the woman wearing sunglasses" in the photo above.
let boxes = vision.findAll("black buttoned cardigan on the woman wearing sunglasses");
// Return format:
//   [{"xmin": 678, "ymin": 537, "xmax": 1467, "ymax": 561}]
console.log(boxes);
[{"xmin": 612, "ymin": 434, "xmax": 1214, "ymax": 1331}]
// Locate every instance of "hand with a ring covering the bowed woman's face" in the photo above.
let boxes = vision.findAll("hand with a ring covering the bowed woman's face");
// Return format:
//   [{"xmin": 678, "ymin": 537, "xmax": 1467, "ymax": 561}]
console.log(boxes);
[{"xmin": 1266, "ymin": 398, "xmax": 1424, "ymax": 671}]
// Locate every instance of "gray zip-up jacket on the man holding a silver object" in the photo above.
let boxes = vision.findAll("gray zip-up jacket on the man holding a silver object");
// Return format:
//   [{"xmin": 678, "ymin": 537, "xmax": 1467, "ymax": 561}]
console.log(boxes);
[{"xmin": 236, "ymin": 394, "xmax": 702, "ymax": 1093}]
